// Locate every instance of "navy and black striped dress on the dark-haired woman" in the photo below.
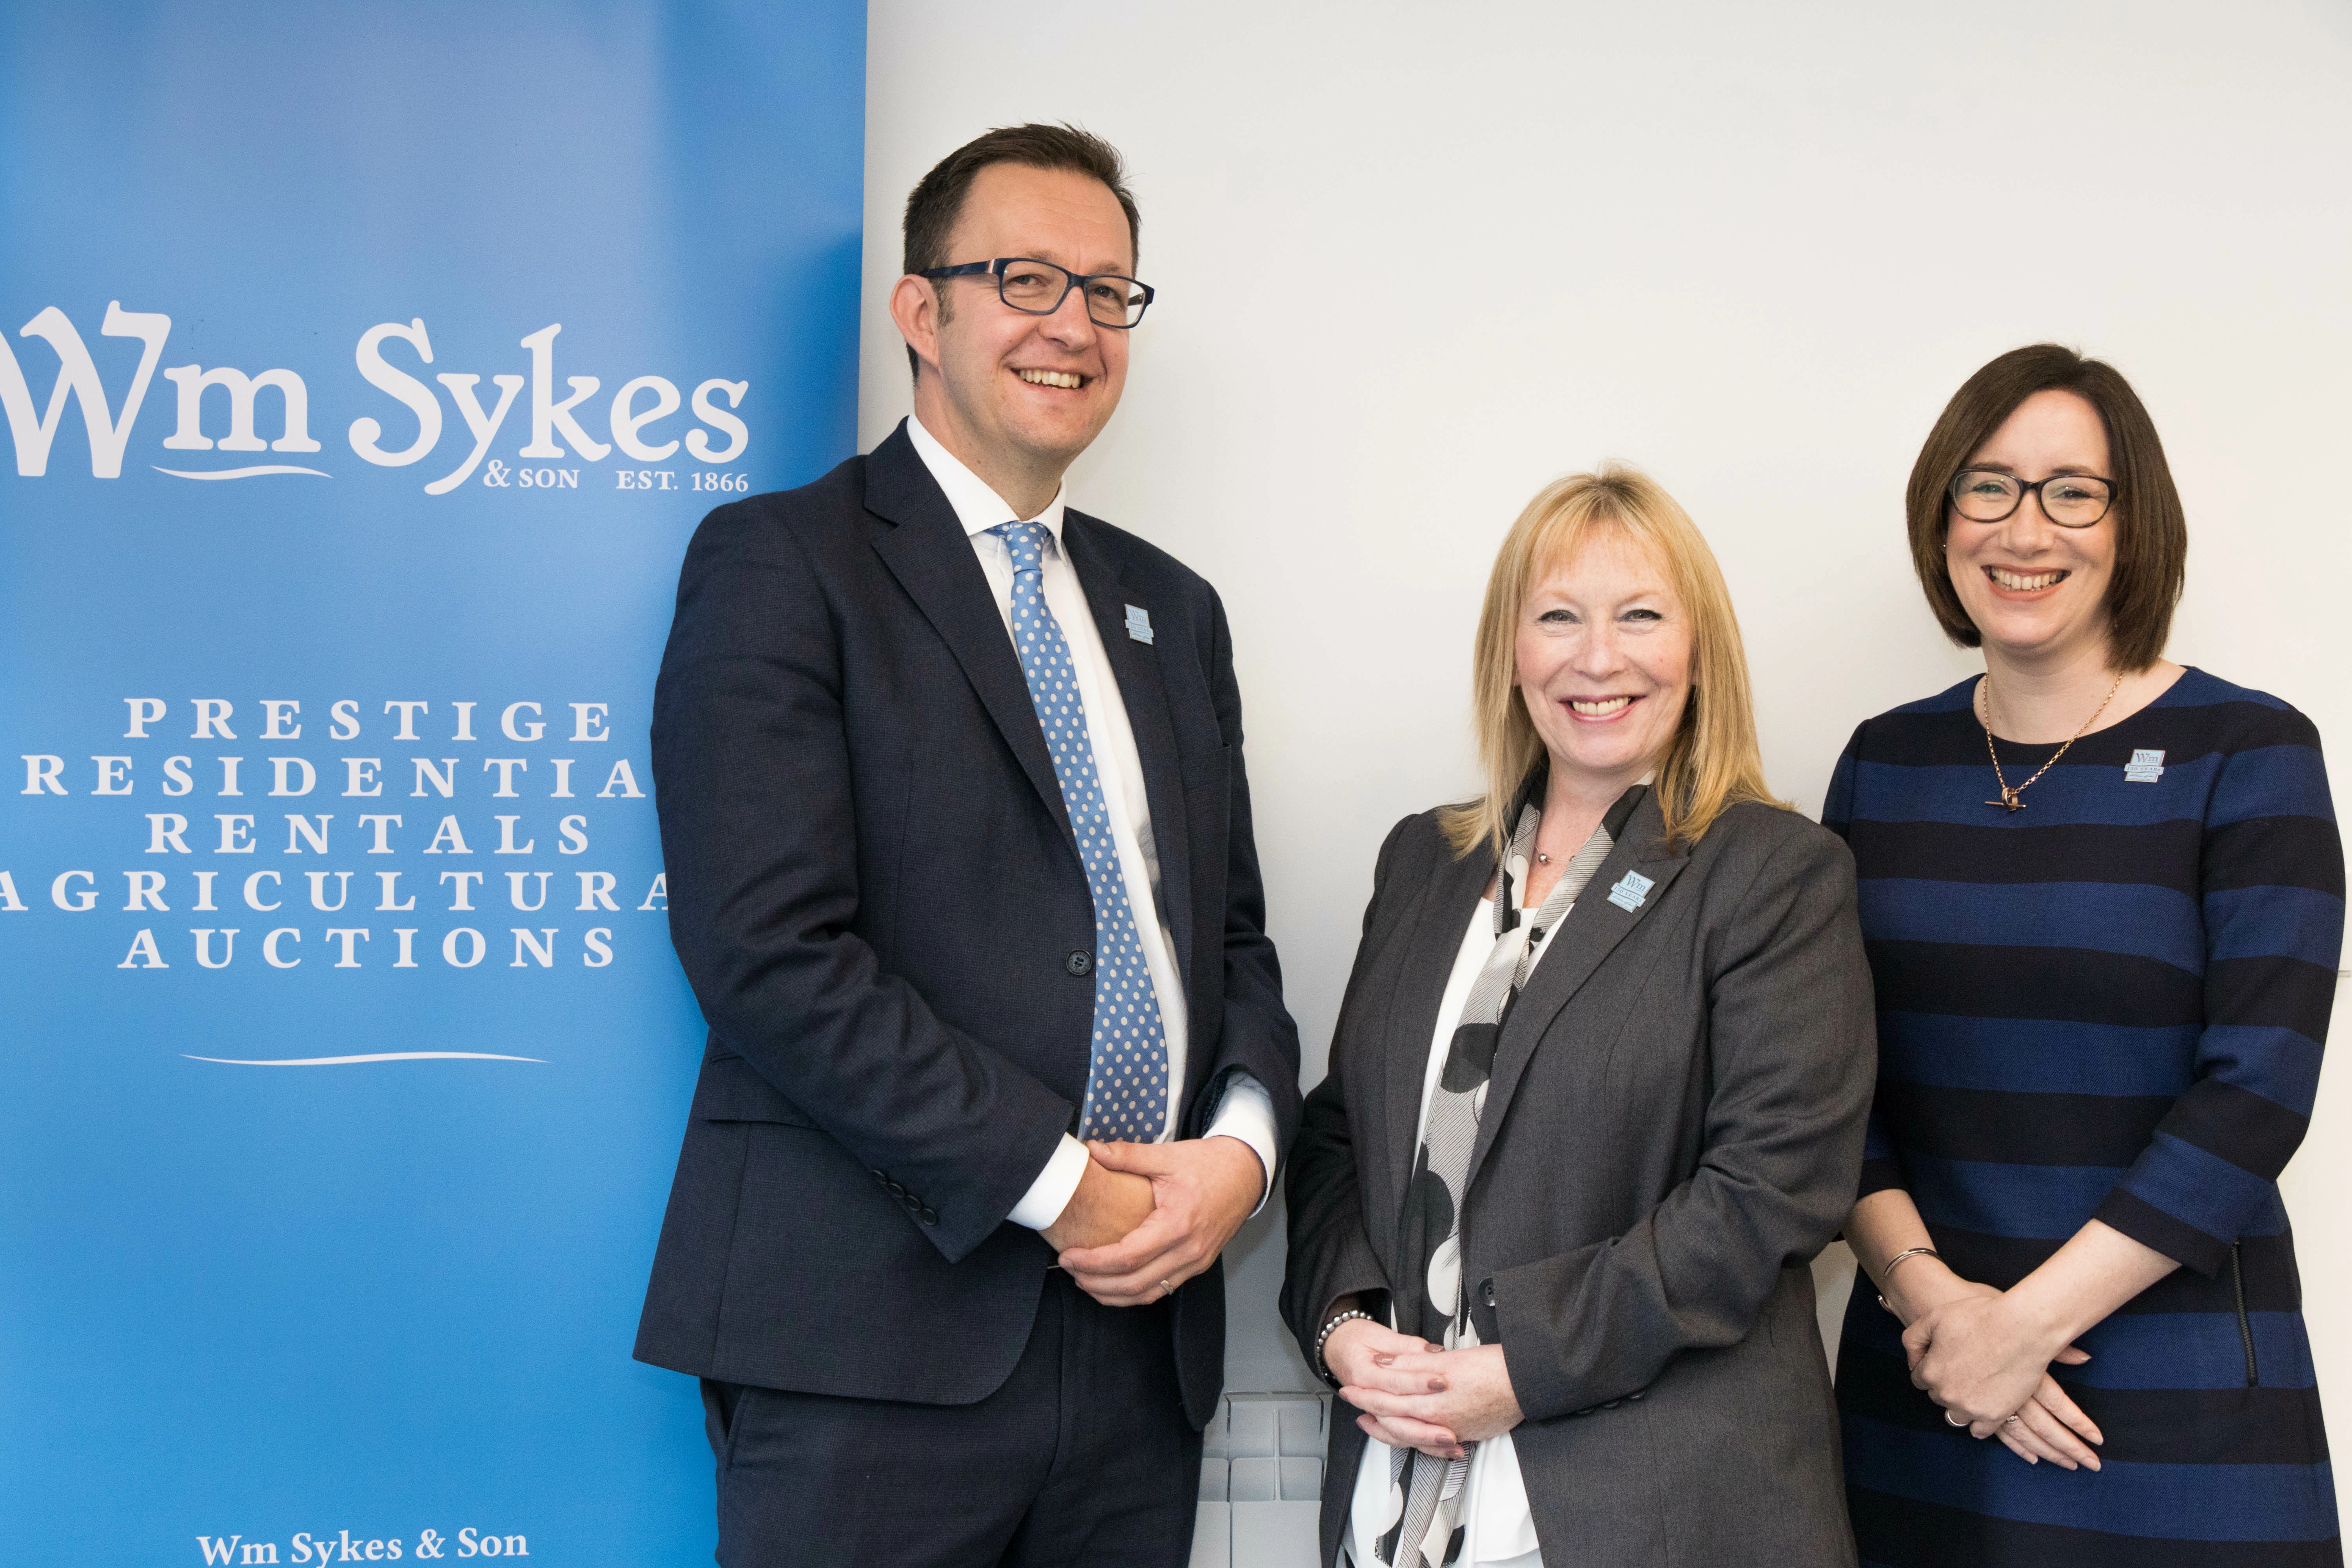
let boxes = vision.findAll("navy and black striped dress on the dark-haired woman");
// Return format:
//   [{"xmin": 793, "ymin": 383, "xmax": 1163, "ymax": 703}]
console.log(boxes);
[{"xmin": 1823, "ymin": 670, "xmax": 2345, "ymax": 1568}]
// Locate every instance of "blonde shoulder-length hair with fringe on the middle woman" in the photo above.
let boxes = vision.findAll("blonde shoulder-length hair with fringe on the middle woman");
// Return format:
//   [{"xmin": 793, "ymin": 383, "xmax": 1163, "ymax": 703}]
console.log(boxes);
[{"xmin": 1439, "ymin": 463, "xmax": 1790, "ymax": 858}]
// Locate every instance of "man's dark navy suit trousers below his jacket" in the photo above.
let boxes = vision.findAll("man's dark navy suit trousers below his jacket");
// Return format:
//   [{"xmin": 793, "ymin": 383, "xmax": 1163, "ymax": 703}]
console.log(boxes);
[{"xmin": 703, "ymin": 1269, "xmax": 1202, "ymax": 1568}]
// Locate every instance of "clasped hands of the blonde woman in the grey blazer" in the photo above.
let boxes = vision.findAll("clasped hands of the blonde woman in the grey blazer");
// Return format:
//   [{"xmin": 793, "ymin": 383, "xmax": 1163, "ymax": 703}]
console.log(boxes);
[{"xmin": 1324, "ymin": 1319, "xmax": 1524, "ymax": 1460}]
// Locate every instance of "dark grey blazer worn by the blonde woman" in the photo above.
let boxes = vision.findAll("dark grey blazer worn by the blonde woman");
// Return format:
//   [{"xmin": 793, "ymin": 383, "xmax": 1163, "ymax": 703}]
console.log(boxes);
[{"xmin": 1282, "ymin": 797, "xmax": 1877, "ymax": 1568}]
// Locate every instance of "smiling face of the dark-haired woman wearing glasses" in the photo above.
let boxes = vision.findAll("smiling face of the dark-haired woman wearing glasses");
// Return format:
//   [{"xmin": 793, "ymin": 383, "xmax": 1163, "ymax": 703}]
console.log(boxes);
[{"xmin": 1943, "ymin": 392, "xmax": 2122, "ymax": 665}]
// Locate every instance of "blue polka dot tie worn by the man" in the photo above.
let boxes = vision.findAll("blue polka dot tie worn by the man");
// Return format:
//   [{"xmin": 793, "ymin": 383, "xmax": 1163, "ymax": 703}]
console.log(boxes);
[{"xmin": 988, "ymin": 522, "xmax": 1169, "ymax": 1143}]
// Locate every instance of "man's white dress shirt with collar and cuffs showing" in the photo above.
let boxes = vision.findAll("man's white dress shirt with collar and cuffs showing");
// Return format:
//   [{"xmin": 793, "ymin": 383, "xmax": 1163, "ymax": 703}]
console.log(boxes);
[{"xmin": 906, "ymin": 416, "xmax": 1275, "ymax": 1229}]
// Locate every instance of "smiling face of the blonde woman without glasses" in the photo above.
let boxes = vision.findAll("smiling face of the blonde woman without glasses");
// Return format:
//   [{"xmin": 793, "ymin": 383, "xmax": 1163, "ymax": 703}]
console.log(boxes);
[{"xmin": 1517, "ymin": 524, "xmax": 1691, "ymax": 795}]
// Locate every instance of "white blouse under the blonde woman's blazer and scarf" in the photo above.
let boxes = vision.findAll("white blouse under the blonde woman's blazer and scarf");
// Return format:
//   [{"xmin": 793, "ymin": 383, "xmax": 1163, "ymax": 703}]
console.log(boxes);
[{"xmin": 1343, "ymin": 858, "xmax": 1573, "ymax": 1568}]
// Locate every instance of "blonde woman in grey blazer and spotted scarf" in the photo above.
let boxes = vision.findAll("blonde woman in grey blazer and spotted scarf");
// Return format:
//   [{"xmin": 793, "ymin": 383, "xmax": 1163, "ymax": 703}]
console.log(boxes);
[{"xmin": 1282, "ymin": 468, "xmax": 1875, "ymax": 1568}]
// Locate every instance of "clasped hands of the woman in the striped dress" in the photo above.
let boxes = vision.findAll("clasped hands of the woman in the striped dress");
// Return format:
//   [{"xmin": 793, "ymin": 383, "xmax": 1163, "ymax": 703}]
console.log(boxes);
[{"xmin": 1903, "ymin": 1258, "xmax": 2105, "ymax": 1469}]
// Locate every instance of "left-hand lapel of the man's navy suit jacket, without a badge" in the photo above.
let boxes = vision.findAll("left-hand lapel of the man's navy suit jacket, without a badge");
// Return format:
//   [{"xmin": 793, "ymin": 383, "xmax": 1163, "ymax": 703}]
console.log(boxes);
[{"xmin": 866, "ymin": 425, "xmax": 1077, "ymax": 853}]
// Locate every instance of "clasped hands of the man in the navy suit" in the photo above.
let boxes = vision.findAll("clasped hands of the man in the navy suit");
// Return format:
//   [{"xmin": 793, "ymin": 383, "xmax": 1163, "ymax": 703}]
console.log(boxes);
[{"xmin": 1042, "ymin": 1136, "xmax": 1265, "ymax": 1307}]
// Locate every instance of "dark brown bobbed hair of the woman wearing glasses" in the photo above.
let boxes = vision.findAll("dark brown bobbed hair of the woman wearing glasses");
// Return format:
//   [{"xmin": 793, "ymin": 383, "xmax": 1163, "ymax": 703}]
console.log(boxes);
[{"xmin": 1905, "ymin": 343, "xmax": 2190, "ymax": 670}]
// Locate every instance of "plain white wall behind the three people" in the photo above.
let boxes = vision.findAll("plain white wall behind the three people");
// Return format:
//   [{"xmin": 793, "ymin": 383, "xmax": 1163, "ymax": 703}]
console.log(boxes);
[{"xmin": 861, "ymin": 0, "xmax": 2352, "ymax": 1434}]
